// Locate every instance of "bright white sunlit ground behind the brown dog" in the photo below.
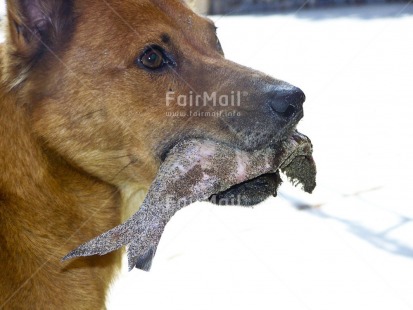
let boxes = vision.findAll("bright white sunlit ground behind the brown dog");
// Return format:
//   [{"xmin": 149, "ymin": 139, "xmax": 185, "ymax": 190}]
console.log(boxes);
[{"xmin": 2, "ymin": 4, "xmax": 413, "ymax": 310}]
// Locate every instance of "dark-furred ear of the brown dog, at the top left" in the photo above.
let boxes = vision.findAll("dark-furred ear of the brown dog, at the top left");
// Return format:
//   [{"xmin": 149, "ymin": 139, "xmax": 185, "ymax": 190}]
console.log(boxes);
[{"xmin": 7, "ymin": 0, "xmax": 73, "ymax": 59}]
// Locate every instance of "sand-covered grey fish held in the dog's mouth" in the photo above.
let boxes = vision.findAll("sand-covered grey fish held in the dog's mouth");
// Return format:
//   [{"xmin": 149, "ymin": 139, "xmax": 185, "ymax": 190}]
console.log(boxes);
[{"xmin": 63, "ymin": 131, "xmax": 317, "ymax": 271}]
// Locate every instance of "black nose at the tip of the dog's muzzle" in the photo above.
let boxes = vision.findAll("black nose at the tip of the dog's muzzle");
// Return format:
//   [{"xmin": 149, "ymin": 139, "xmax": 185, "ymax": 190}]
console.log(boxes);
[{"xmin": 269, "ymin": 85, "xmax": 305, "ymax": 118}]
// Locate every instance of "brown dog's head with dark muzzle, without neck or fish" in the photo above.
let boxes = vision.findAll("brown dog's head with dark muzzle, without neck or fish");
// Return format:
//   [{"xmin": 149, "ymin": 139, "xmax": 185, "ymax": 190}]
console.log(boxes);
[{"xmin": 3, "ymin": 0, "xmax": 305, "ymax": 206}]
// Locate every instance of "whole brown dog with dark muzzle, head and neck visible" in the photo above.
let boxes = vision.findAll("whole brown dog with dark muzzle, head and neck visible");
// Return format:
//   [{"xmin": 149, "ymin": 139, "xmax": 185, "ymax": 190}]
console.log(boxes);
[{"xmin": 0, "ymin": 0, "xmax": 305, "ymax": 309}]
